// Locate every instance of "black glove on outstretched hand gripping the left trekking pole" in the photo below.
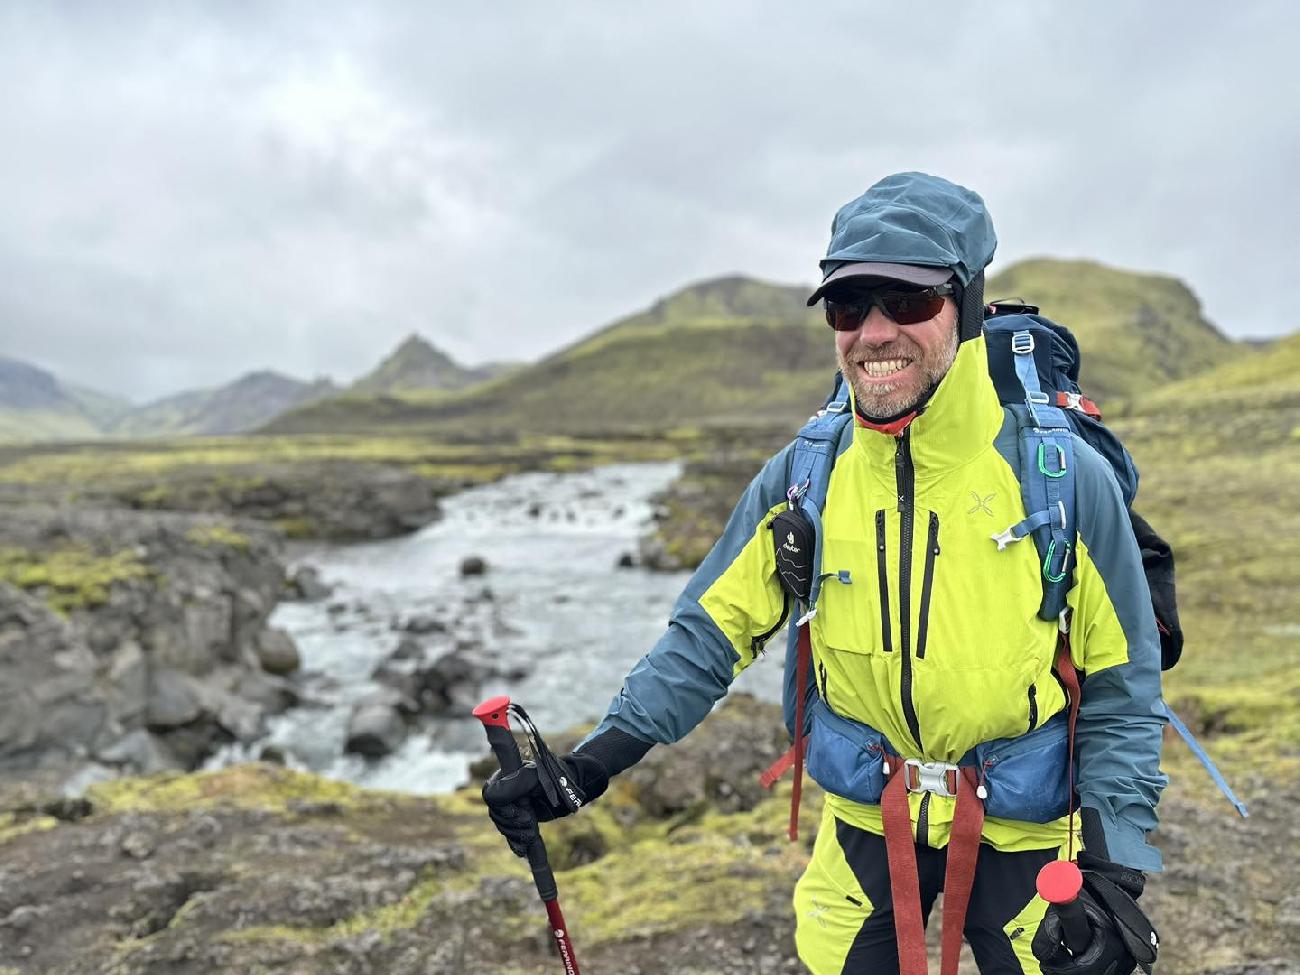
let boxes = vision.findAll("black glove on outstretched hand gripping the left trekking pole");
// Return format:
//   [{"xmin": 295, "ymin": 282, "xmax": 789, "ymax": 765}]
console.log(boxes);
[{"xmin": 484, "ymin": 751, "xmax": 610, "ymax": 857}]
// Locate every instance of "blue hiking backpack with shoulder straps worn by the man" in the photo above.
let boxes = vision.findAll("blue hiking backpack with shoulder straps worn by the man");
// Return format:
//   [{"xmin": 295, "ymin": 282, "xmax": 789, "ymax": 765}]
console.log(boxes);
[{"xmin": 761, "ymin": 303, "xmax": 1248, "ymax": 839}]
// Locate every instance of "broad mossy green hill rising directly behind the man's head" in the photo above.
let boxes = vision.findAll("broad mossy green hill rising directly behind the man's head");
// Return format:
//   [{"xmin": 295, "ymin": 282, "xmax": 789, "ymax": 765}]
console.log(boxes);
[{"xmin": 267, "ymin": 260, "xmax": 1244, "ymax": 436}]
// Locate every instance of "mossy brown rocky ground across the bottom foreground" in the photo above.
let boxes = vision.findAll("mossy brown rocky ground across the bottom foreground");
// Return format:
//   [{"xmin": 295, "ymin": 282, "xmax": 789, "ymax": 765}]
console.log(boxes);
[{"xmin": 0, "ymin": 696, "xmax": 1284, "ymax": 975}]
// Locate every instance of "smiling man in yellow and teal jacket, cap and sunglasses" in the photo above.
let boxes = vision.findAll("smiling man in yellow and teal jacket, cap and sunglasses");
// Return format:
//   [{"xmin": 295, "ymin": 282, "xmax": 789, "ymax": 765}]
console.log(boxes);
[{"xmin": 484, "ymin": 173, "xmax": 1165, "ymax": 975}]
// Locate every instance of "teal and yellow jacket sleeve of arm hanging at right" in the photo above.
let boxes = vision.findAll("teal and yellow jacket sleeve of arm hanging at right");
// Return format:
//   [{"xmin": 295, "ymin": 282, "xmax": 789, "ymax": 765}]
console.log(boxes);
[{"xmin": 1071, "ymin": 441, "xmax": 1167, "ymax": 871}]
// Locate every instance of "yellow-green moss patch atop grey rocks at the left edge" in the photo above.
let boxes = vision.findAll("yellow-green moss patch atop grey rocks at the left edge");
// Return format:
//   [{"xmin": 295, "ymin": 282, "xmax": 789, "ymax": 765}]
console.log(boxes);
[{"xmin": 0, "ymin": 545, "xmax": 153, "ymax": 615}]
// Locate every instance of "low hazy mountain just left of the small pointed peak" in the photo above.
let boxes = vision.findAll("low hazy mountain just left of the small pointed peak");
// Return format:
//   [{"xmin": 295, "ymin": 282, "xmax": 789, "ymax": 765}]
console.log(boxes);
[{"xmin": 108, "ymin": 371, "xmax": 338, "ymax": 437}]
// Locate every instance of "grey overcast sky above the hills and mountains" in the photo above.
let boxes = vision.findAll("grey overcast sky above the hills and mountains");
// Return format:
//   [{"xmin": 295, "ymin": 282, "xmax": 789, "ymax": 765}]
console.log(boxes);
[{"xmin": 0, "ymin": 0, "xmax": 1300, "ymax": 402}]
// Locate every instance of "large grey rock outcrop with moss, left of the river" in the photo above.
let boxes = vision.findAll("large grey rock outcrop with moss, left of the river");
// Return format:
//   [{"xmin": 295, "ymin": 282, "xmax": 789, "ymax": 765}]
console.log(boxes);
[{"xmin": 0, "ymin": 507, "xmax": 296, "ymax": 774}]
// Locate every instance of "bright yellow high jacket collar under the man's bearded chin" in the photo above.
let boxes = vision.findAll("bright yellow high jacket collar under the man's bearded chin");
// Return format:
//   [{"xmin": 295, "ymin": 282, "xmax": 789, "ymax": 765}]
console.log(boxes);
[{"xmin": 853, "ymin": 335, "xmax": 1002, "ymax": 475}]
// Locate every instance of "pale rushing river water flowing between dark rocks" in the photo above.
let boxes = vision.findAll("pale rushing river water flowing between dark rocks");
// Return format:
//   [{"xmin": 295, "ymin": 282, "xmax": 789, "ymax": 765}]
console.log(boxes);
[{"xmin": 213, "ymin": 463, "xmax": 781, "ymax": 793}]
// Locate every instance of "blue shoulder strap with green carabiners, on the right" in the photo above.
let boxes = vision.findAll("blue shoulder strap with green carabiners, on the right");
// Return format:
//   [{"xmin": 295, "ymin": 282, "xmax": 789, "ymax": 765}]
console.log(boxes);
[{"xmin": 993, "ymin": 329, "xmax": 1078, "ymax": 620}]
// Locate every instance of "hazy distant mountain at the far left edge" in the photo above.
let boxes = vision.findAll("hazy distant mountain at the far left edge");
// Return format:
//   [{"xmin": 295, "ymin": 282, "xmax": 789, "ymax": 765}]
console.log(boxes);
[{"xmin": 0, "ymin": 356, "xmax": 131, "ymax": 441}]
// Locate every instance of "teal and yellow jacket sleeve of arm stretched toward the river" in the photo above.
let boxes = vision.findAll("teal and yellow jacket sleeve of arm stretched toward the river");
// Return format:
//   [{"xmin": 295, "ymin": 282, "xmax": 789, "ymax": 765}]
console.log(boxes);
[{"xmin": 579, "ymin": 446, "xmax": 792, "ymax": 749}]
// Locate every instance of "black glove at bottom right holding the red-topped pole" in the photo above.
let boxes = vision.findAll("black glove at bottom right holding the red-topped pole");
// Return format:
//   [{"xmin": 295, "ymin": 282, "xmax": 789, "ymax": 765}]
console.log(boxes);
[{"xmin": 1031, "ymin": 852, "xmax": 1160, "ymax": 975}]
